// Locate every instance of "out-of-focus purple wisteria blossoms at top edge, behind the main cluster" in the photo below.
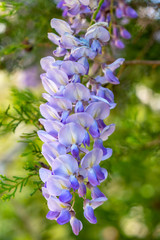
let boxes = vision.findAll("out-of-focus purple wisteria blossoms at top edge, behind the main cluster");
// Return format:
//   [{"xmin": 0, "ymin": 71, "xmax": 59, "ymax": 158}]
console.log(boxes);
[{"xmin": 57, "ymin": 0, "xmax": 138, "ymax": 49}]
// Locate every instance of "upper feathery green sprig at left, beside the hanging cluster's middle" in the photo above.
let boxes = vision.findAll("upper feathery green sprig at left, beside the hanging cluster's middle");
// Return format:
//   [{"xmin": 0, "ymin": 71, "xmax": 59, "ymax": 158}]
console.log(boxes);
[{"xmin": 0, "ymin": 88, "xmax": 41, "ymax": 135}]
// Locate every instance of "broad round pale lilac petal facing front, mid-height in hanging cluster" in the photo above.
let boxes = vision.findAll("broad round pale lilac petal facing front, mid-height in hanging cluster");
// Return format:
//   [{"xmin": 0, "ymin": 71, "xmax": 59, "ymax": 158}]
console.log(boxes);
[{"xmin": 58, "ymin": 123, "xmax": 85, "ymax": 146}]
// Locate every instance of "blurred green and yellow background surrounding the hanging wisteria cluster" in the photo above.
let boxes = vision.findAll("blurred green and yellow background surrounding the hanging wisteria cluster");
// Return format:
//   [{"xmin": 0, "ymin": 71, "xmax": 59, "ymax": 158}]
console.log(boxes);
[{"xmin": 0, "ymin": 0, "xmax": 160, "ymax": 240}]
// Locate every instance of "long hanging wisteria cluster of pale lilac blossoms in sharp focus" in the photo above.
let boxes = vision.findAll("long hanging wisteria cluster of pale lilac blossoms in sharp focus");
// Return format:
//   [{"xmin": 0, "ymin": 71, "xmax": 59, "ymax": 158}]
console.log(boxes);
[{"xmin": 38, "ymin": 0, "xmax": 129, "ymax": 235}]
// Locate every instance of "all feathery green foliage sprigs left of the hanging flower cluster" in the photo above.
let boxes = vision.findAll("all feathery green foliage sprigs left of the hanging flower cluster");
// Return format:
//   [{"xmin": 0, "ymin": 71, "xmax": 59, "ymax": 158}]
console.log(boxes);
[{"xmin": 0, "ymin": 88, "xmax": 47, "ymax": 200}]
